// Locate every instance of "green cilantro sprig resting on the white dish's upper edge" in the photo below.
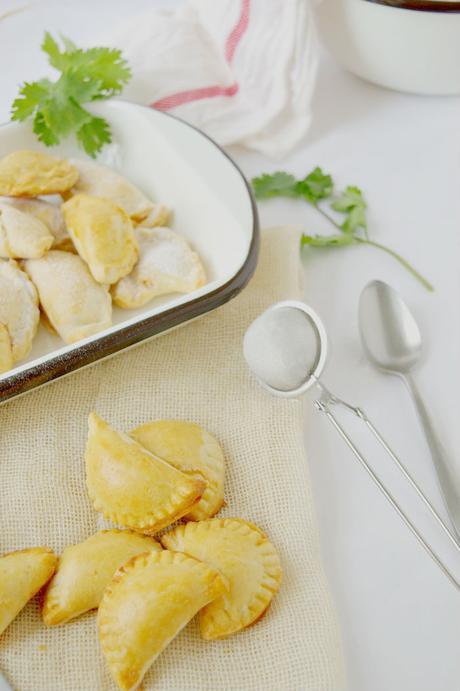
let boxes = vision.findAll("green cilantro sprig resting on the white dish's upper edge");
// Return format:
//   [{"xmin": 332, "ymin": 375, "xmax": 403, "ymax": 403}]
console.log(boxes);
[{"xmin": 11, "ymin": 33, "xmax": 131, "ymax": 158}]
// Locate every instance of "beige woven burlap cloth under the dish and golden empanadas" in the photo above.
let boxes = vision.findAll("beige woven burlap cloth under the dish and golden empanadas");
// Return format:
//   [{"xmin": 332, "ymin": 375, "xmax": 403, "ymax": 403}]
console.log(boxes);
[{"xmin": 0, "ymin": 228, "xmax": 343, "ymax": 691}]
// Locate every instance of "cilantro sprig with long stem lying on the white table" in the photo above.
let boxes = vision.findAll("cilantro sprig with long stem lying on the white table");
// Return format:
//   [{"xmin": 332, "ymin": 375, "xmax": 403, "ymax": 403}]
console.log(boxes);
[{"xmin": 252, "ymin": 167, "xmax": 434, "ymax": 291}]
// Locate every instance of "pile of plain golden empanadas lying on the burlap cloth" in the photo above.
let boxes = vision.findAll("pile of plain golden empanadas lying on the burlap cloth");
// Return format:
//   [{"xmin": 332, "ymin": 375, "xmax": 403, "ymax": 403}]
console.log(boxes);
[{"xmin": 0, "ymin": 414, "xmax": 281, "ymax": 691}]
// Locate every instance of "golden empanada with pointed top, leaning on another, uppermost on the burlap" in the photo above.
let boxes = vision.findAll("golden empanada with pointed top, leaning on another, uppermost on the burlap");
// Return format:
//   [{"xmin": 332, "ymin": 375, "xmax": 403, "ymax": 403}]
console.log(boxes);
[{"xmin": 85, "ymin": 413, "xmax": 206, "ymax": 534}]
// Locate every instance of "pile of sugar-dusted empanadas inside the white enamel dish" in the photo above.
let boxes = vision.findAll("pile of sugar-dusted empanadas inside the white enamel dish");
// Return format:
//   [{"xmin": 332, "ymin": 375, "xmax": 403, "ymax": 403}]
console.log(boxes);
[{"xmin": 0, "ymin": 151, "xmax": 206, "ymax": 373}]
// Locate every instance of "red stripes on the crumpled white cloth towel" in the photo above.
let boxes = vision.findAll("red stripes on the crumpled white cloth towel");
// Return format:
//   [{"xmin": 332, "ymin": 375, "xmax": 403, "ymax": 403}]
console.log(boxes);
[{"xmin": 150, "ymin": 0, "xmax": 251, "ymax": 110}]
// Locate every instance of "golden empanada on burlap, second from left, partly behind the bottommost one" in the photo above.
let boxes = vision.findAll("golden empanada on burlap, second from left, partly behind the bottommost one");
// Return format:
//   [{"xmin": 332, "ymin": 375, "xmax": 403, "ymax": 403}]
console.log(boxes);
[{"xmin": 43, "ymin": 529, "xmax": 161, "ymax": 626}]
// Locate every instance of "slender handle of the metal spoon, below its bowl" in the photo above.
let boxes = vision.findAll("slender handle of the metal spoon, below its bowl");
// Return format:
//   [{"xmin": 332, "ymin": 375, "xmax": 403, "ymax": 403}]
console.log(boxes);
[{"xmin": 403, "ymin": 374, "xmax": 460, "ymax": 536}]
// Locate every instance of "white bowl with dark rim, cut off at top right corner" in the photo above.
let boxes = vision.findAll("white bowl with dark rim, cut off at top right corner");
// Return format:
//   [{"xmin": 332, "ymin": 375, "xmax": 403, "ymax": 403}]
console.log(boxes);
[{"xmin": 317, "ymin": 0, "xmax": 460, "ymax": 95}]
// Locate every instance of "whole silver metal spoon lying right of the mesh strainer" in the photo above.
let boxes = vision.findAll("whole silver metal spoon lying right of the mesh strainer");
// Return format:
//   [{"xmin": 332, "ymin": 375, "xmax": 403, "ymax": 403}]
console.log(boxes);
[{"xmin": 359, "ymin": 281, "xmax": 460, "ymax": 537}]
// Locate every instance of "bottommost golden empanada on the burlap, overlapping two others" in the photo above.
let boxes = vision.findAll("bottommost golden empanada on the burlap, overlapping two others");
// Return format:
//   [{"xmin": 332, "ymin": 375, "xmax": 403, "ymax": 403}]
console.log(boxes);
[{"xmin": 98, "ymin": 551, "xmax": 226, "ymax": 691}]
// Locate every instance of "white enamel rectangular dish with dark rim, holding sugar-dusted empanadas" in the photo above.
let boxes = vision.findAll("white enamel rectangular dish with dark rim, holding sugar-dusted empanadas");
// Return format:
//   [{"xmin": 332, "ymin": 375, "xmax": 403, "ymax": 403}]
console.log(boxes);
[{"xmin": 0, "ymin": 101, "xmax": 259, "ymax": 403}]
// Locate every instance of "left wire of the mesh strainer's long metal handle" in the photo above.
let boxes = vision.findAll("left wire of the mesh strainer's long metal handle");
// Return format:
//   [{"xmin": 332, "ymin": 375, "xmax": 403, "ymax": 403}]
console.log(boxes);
[{"xmin": 315, "ymin": 397, "xmax": 460, "ymax": 589}]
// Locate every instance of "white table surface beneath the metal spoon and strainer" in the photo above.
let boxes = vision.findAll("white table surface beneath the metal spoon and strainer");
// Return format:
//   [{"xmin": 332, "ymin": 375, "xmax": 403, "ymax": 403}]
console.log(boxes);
[{"xmin": 0, "ymin": 0, "xmax": 460, "ymax": 691}]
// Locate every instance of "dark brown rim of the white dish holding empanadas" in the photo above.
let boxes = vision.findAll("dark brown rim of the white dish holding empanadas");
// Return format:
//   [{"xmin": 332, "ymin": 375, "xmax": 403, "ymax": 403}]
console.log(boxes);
[{"xmin": 0, "ymin": 103, "xmax": 260, "ymax": 403}]
